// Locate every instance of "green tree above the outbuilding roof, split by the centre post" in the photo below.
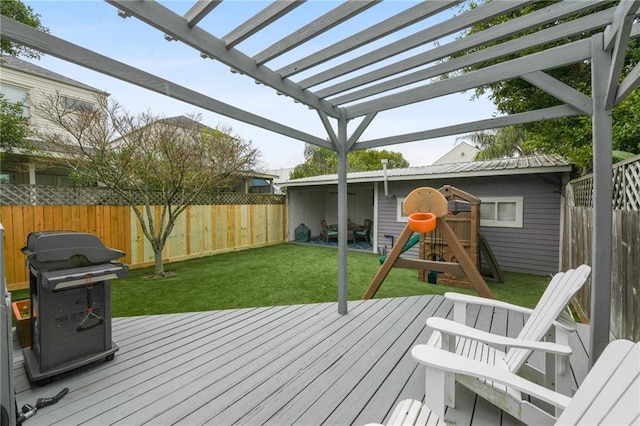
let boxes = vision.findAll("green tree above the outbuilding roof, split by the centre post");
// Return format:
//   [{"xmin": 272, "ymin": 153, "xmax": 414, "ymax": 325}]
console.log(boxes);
[{"xmin": 289, "ymin": 144, "xmax": 409, "ymax": 179}]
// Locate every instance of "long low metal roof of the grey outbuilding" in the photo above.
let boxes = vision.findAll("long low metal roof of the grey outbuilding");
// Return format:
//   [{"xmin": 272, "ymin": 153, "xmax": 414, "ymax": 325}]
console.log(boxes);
[{"xmin": 278, "ymin": 155, "xmax": 572, "ymax": 187}]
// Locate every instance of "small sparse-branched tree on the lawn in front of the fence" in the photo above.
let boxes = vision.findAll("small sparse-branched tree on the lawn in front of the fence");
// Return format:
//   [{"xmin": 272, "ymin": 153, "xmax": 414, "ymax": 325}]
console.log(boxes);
[{"xmin": 34, "ymin": 94, "xmax": 259, "ymax": 276}]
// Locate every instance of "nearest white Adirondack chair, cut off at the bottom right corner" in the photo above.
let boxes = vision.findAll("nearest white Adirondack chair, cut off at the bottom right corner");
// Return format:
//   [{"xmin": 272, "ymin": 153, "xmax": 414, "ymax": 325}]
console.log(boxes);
[{"xmin": 368, "ymin": 340, "xmax": 640, "ymax": 425}]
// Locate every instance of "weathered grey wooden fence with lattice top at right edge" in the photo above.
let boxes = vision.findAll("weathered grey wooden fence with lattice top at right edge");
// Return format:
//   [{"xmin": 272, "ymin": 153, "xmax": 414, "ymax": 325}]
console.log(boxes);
[{"xmin": 562, "ymin": 155, "xmax": 640, "ymax": 342}]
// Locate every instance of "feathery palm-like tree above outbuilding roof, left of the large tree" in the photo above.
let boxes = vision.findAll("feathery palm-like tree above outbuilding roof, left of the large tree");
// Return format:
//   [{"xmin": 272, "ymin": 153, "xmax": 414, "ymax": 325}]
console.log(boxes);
[{"xmin": 456, "ymin": 126, "xmax": 534, "ymax": 160}]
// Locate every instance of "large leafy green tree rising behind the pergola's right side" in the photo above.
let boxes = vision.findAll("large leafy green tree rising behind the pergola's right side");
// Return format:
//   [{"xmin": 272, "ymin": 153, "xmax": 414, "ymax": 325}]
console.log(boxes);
[{"xmin": 457, "ymin": 0, "xmax": 640, "ymax": 171}]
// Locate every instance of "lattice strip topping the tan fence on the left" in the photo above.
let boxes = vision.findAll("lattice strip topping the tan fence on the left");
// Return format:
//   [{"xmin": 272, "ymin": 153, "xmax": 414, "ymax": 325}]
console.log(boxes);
[{"xmin": 0, "ymin": 184, "xmax": 285, "ymax": 206}]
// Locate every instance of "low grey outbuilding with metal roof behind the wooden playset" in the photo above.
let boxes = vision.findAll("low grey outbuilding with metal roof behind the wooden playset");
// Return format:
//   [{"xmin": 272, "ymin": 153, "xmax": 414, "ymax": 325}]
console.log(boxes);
[{"xmin": 282, "ymin": 155, "xmax": 572, "ymax": 274}]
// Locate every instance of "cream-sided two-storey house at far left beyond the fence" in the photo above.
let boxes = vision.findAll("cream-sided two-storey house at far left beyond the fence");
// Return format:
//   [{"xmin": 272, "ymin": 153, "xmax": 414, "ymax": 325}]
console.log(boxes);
[{"xmin": 0, "ymin": 56, "xmax": 108, "ymax": 186}]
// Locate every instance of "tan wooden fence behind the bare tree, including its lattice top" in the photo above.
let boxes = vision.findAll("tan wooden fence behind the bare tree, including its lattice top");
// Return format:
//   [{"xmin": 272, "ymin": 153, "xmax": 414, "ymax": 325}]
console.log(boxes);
[{"xmin": 0, "ymin": 184, "xmax": 286, "ymax": 290}]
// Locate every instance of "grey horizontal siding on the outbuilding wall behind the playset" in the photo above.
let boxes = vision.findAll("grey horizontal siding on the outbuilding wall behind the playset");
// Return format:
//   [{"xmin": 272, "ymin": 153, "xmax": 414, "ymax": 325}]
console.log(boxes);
[{"xmin": 377, "ymin": 174, "xmax": 561, "ymax": 275}]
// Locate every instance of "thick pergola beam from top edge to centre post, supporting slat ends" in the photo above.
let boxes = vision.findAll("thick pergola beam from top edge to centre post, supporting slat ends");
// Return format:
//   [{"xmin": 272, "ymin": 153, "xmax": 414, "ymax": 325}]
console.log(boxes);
[{"xmin": 105, "ymin": 0, "xmax": 340, "ymax": 117}]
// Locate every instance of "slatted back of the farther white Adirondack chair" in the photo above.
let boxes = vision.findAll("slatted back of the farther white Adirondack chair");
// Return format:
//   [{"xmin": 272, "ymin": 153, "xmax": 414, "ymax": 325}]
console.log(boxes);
[{"xmin": 505, "ymin": 265, "xmax": 591, "ymax": 373}]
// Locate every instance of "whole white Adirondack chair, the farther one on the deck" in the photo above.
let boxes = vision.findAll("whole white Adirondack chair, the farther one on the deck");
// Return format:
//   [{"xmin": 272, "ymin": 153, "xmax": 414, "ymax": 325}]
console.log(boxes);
[{"xmin": 425, "ymin": 265, "xmax": 591, "ymax": 423}]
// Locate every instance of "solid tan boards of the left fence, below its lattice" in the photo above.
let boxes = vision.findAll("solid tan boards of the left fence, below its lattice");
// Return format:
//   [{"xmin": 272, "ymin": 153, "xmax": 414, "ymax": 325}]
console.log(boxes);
[{"xmin": 0, "ymin": 185, "xmax": 286, "ymax": 290}]
